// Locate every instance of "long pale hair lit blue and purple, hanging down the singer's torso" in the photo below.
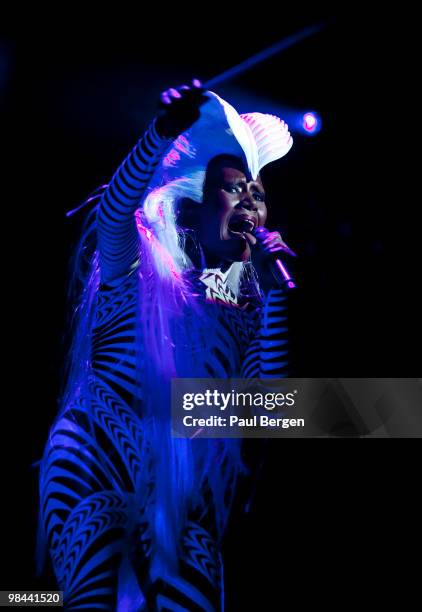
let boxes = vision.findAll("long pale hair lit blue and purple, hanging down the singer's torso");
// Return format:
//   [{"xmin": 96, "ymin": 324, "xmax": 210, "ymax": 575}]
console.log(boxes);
[{"xmin": 136, "ymin": 170, "xmax": 260, "ymax": 564}]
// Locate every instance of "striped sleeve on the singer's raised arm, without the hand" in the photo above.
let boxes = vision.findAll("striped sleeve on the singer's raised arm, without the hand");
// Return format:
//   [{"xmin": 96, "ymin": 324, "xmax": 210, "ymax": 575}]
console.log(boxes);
[{"xmin": 97, "ymin": 120, "xmax": 171, "ymax": 282}]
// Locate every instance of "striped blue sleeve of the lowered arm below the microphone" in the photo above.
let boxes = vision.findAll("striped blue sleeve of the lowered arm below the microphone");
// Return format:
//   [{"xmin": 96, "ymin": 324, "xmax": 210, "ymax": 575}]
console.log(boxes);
[{"xmin": 242, "ymin": 288, "xmax": 289, "ymax": 378}]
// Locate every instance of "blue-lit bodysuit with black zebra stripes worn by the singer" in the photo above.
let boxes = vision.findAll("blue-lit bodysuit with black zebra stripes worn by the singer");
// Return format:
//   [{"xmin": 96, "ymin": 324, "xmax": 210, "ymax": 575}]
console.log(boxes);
[{"xmin": 40, "ymin": 124, "xmax": 287, "ymax": 611}]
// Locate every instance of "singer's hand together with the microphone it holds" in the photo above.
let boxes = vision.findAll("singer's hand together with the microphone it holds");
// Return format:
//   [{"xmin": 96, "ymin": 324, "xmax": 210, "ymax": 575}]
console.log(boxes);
[{"xmin": 252, "ymin": 227, "xmax": 297, "ymax": 290}]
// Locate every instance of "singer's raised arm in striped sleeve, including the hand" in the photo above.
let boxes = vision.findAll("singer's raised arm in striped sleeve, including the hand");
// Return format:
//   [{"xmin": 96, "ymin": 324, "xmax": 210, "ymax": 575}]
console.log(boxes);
[{"xmin": 97, "ymin": 80, "xmax": 206, "ymax": 282}]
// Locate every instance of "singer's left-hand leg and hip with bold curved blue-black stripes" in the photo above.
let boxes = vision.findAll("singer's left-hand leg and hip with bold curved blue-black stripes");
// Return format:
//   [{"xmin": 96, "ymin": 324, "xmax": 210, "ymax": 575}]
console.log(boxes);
[{"xmin": 40, "ymin": 386, "xmax": 148, "ymax": 611}]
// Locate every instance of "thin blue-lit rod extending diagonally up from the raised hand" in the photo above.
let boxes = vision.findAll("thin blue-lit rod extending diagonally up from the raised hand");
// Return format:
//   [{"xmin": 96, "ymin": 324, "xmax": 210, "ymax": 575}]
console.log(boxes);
[{"xmin": 204, "ymin": 21, "xmax": 327, "ymax": 89}]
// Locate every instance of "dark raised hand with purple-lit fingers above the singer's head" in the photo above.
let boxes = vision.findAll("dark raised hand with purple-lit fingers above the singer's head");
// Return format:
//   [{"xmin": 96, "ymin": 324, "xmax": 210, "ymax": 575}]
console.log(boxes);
[{"xmin": 155, "ymin": 79, "xmax": 208, "ymax": 138}]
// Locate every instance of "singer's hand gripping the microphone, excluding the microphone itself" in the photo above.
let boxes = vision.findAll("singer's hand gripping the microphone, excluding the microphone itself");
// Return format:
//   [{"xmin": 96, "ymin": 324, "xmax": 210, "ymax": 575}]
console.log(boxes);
[{"xmin": 251, "ymin": 227, "xmax": 297, "ymax": 293}]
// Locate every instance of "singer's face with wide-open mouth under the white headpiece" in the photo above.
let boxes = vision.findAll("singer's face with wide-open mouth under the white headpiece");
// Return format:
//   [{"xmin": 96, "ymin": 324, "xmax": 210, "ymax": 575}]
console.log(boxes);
[{"xmin": 198, "ymin": 158, "xmax": 267, "ymax": 265}]
